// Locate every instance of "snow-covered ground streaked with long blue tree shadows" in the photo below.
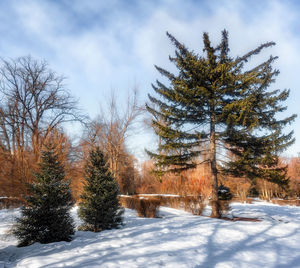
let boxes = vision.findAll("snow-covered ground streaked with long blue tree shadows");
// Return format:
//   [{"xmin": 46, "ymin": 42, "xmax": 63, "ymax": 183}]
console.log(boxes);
[{"xmin": 0, "ymin": 202, "xmax": 300, "ymax": 268}]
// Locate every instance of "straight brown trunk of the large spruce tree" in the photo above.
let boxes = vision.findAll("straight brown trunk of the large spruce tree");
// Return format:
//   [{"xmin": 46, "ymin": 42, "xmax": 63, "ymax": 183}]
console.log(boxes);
[{"xmin": 210, "ymin": 114, "xmax": 221, "ymax": 218}]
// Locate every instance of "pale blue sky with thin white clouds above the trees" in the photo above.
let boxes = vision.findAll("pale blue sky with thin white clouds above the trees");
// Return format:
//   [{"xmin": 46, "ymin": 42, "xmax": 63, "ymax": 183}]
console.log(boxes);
[{"xmin": 0, "ymin": 0, "xmax": 300, "ymax": 158}]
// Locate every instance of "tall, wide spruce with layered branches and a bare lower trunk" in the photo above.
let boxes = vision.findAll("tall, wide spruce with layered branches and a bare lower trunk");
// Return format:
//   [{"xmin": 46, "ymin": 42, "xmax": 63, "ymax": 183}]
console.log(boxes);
[{"xmin": 147, "ymin": 30, "xmax": 296, "ymax": 217}]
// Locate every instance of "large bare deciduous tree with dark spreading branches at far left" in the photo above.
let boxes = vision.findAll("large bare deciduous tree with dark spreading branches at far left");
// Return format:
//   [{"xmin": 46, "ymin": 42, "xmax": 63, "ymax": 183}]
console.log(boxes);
[{"xmin": 0, "ymin": 56, "xmax": 84, "ymax": 195}]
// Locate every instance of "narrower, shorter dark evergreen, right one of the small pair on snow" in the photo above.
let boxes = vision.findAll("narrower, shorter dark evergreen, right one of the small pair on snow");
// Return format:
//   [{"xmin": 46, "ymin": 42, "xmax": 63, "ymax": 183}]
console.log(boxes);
[{"xmin": 79, "ymin": 147, "xmax": 123, "ymax": 232}]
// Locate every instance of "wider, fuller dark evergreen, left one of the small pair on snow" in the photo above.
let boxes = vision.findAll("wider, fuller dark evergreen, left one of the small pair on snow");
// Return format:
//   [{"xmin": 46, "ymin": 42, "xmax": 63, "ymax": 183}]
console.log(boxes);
[{"xmin": 13, "ymin": 143, "xmax": 74, "ymax": 246}]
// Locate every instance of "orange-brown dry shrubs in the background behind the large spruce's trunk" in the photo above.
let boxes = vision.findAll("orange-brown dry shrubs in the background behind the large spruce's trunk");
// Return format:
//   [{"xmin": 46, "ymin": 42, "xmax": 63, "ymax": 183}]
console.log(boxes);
[{"xmin": 135, "ymin": 157, "xmax": 300, "ymax": 202}]
